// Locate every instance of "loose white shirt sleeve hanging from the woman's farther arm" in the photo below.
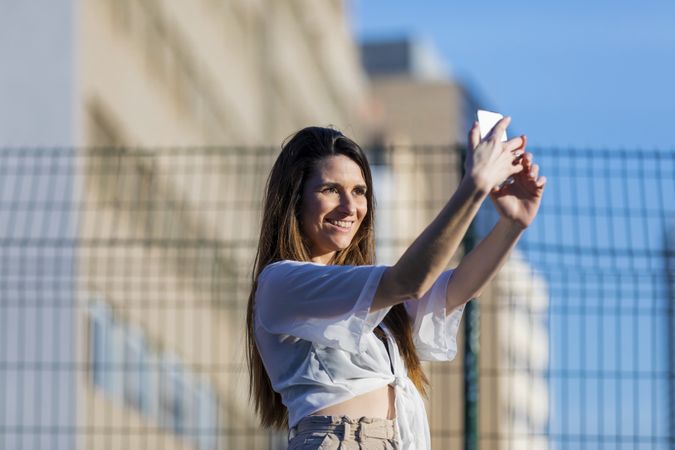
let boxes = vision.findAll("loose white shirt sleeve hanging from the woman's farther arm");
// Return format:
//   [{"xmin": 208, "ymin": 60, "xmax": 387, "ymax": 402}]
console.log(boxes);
[{"xmin": 404, "ymin": 270, "xmax": 464, "ymax": 361}]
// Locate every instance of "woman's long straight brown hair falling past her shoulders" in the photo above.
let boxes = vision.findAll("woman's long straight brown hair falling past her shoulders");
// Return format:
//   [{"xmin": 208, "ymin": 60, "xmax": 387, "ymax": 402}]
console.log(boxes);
[{"xmin": 246, "ymin": 127, "xmax": 429, "ymax": 429}]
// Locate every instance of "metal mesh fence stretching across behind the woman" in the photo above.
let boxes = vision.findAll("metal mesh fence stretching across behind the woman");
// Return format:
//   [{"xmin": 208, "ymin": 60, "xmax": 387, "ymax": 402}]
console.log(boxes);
[{"xmin": 0, "ymin": 147, "xmax": 675, "ymax": 450}]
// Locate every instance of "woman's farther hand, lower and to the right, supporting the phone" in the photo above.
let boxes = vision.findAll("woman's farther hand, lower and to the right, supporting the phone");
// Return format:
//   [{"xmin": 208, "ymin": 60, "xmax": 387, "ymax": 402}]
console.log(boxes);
[{"xmin": 490, "ymin": 153, "xmax": 546, "ymax": 228}]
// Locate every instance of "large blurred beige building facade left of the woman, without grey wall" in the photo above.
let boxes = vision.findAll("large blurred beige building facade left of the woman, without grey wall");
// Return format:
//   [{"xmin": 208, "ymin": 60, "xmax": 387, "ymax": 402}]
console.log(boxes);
[{"xmin": 77, "ymin": 0, "xmax": 378, "ymax": 450}]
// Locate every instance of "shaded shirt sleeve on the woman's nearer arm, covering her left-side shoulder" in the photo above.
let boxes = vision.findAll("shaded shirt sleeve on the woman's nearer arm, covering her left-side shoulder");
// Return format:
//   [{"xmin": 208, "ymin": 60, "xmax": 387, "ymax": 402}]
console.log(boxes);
[{"xmin": 255, "ymin": 261, "xmax": 391, "ymax": 353}]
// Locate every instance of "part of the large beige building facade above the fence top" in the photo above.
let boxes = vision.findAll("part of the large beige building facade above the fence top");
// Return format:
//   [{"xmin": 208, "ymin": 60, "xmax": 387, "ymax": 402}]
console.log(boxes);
[{"xmin": 82, "ymin": 0, "xmax": 368, "ymax": 147}]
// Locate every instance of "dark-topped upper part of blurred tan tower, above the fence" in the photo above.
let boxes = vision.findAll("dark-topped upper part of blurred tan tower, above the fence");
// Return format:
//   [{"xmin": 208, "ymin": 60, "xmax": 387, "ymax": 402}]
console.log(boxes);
[{"xmin": 361, "ymin": 37, "xmax": 479, "ymax": 146}]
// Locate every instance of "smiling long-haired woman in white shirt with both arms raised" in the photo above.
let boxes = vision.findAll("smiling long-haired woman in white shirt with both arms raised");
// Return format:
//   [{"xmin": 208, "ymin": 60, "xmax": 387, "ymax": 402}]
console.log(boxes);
[{"xmin": 247, "ymin": 117, "xmax": 546, "ymax": 450}]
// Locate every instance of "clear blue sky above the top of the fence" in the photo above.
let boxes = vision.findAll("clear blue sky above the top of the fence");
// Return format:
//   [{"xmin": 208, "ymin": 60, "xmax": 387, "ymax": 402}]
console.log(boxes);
[{"xmin": 351, "ymin": 0, "xmax": 675, "ymax": 149}]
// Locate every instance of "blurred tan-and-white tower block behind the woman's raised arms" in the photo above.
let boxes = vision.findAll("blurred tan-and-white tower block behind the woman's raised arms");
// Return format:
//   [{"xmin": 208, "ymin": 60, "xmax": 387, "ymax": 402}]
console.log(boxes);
[{"xmin": 361, "ymin": 38, "xmax": 549, "ymax": 449}]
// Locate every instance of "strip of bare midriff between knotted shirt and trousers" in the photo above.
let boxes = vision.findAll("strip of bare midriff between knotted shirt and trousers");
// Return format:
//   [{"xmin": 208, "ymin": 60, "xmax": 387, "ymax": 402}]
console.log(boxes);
[{"xmin": 311, "ymin": 385, "xmax": 396, "ymax": 419}]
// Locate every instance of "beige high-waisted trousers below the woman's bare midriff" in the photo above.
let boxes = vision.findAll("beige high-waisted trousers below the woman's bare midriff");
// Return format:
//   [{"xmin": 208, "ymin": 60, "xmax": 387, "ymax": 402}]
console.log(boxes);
[{"xmin": 288, "ymin": 416, "xmax": 400, "ymax": 450}]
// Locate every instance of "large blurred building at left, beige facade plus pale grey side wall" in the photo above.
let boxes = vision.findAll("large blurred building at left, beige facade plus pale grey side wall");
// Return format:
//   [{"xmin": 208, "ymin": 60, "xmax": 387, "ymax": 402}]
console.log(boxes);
[{"xmin": 0, "ymin": 0, "xmax": 370, "ymax": 449}]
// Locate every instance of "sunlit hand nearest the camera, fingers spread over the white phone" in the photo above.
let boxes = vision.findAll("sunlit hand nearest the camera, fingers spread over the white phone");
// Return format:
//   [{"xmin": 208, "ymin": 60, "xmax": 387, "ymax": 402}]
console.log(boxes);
[{"xmin": 464, "ymin": 117, "xmax": 525, "ymax": 194}]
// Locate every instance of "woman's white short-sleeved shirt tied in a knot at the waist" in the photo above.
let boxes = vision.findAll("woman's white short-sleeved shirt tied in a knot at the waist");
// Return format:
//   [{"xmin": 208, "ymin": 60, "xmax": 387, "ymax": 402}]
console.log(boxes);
[{"xmin": 254, "ymin": 261, "xmax": 464, "ymax": 450}]
